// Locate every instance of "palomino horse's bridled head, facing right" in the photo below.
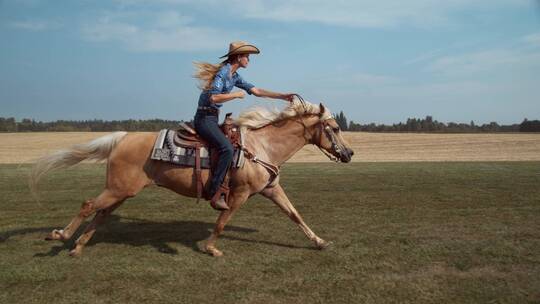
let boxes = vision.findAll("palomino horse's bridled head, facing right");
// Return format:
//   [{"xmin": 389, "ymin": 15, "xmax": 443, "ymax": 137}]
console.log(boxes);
[{"xmin": 312, "ymin": 103, "xmax": 354, "ymax": 163}]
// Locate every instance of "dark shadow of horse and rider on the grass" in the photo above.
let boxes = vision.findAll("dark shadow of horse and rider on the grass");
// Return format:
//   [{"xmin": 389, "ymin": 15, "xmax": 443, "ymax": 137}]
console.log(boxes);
[{"xmin": 4, "ymin": 215, "xmax": 314, "ymax": 257}]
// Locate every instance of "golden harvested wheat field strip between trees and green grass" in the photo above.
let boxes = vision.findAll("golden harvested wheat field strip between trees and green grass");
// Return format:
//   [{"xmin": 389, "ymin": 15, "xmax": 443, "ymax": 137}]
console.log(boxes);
[{"xmin": 0, "ymin": 132, "xmax": 540, "ymax": 164}]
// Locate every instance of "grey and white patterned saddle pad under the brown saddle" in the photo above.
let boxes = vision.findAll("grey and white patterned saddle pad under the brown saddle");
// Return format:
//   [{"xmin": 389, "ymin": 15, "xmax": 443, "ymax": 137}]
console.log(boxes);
[{"xmin": 150, "ymin": 129, "xmax": 244, "ymax": 169}]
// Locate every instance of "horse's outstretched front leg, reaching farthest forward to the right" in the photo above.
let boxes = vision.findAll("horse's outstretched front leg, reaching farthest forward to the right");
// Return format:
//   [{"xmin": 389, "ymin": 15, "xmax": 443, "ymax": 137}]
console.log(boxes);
[{"xmin": 261, "ymin": 184, "xmax": 332, "ymax": 249}]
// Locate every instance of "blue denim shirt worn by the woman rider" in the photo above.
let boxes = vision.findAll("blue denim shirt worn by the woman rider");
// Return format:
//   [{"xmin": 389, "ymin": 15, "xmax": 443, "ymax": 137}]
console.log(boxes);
[{"xmin": 199, "ymin": 63, "xmax": 255, "ymax": 109}]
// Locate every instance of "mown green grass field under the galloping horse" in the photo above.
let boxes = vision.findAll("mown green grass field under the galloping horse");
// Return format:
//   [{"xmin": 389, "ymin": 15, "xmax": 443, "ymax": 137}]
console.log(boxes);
[{"xmin": 0, "ymin": 162, "xmax": 540, "ymax": 304}]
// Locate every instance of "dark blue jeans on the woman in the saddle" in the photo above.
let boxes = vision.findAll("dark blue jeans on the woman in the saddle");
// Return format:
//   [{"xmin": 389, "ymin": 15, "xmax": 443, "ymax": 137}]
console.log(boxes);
[{"xmin": 193, "ymin": 113, "xmax": 234, "ymax": 196}]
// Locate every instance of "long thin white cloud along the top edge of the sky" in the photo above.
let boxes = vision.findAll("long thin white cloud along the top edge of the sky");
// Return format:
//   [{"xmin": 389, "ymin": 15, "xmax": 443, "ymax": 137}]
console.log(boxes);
[{"xmin": 110, "ymin": 0, "xmax": 534, "ymax": 28}]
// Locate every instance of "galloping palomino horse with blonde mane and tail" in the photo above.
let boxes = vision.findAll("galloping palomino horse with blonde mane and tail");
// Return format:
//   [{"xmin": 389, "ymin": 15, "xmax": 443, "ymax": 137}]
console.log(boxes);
[{"xmin": 30, "ymin": 99, "xmax": 353, "ymax": 256}]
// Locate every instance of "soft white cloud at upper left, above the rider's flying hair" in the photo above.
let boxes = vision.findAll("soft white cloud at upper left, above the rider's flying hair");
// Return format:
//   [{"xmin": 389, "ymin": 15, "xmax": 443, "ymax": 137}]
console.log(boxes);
[{"xmin": 82, "ymin": 11, "xmax": 236, "ymax": 52}]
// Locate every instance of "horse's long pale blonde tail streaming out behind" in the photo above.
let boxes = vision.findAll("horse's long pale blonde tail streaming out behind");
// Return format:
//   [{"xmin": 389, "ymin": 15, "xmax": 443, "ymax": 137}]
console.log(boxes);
[{"xmin": 29, "ymin": 132, "xmax": 127, "ymax": 198}]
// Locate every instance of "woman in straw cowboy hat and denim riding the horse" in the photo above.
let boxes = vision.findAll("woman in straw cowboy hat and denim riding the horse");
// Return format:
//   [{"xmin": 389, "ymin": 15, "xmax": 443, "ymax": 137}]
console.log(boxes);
[{"xmin": 194, "ymin": 41, "xmax": 295, "ymax": 210}]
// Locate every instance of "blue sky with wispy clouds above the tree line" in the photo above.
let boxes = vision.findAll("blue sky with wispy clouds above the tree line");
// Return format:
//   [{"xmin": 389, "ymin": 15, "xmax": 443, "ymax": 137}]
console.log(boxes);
[{"xmin": 0, "ymin": 0, "xmax": 540, "ymax": 124}]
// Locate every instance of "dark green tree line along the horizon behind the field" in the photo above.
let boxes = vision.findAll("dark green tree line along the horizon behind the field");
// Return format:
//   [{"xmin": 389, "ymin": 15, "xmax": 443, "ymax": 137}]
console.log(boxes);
[{"xmin": 0, "ymin": 111, "xmax": 540, "ymax": 133}]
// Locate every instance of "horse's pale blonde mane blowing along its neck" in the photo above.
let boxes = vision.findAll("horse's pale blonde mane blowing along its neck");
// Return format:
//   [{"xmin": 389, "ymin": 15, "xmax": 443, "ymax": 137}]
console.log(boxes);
[{"xmin": 235, "ymin": 98, "xmax": 331, "ymax": 129}]
